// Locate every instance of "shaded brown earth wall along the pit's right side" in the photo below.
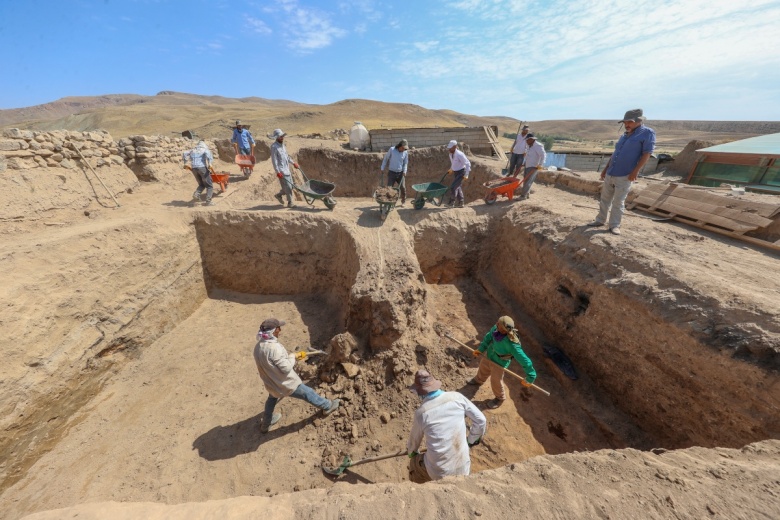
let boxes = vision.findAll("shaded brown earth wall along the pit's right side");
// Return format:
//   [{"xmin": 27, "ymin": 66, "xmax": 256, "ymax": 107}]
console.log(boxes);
[{"xmin": 415, "ymin": 208, "xmax": 780, "ymax": 448}]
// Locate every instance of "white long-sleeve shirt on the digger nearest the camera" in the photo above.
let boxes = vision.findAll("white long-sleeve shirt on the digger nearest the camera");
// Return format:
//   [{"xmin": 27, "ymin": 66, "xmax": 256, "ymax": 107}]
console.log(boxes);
[{"xmin": 406, "ymin": 392, "xmax": 487, "ymax": 480}]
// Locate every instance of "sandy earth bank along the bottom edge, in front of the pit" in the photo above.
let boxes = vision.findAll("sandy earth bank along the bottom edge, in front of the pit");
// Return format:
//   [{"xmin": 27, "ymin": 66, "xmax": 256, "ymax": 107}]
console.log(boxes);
[{"xmin": 25, "ymin": 441, "xmax": 780, "ymax": 520}]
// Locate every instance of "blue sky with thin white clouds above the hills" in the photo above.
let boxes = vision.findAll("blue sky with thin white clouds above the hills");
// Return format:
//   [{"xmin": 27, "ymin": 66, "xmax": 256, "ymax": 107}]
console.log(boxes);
[{"xmin": 0, "ymin": 0, "xmax": 780, "ymax": 121}]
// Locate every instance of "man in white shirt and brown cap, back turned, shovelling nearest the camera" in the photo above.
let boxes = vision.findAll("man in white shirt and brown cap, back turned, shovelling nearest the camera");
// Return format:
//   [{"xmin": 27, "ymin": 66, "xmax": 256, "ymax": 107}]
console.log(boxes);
[{"xmin": 406, "ymin": 370, "xmax": 487, "ymax": 484}]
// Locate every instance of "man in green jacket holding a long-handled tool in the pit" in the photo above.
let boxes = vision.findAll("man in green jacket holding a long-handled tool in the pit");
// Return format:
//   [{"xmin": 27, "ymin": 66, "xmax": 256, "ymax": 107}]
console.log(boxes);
[{"xmin": 468, "ymin": 316, "xmax": 536, "ymax": 408}]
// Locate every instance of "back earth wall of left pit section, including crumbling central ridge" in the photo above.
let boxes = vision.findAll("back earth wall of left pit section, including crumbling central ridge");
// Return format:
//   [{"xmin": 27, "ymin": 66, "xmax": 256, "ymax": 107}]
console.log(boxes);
[{"xmin": 196, "ymin": 212, "xmax": 425, "ymax": 358}]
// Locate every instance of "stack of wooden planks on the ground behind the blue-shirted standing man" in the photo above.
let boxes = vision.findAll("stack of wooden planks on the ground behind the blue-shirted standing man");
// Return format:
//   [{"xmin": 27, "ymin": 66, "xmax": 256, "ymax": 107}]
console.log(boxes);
[{"xmin": 630, "ymin": 183, "xmax": 780, "ymax": 250}]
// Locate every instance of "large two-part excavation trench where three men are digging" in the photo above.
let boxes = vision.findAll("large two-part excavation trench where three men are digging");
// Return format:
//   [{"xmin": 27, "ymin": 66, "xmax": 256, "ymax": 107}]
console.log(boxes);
[{"xmin": 3, "ymin": 146, "xmax": 780, "ymax": 513}]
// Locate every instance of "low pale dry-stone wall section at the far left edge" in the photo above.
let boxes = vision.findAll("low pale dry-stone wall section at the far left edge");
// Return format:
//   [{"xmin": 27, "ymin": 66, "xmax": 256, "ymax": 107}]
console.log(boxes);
[{"xmin": 0, "ymin": 128, "xmax": 124, "ymax": 172}]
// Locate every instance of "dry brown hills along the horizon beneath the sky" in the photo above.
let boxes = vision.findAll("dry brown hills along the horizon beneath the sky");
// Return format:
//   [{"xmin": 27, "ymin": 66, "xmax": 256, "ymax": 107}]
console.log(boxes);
[{"xmin": 0, "ymin": 91, "xmax": 780, "ymax": 151}]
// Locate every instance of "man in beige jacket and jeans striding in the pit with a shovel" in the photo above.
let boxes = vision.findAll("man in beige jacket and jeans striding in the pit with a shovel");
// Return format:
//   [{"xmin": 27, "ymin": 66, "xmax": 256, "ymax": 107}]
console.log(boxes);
[{"xmin": 254, "ymin": 318, "xmax": 341, "ymax": 433}]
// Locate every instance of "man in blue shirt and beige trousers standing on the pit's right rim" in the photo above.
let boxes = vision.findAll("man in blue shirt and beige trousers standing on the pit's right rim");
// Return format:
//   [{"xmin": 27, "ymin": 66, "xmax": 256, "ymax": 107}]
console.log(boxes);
[{"xmin": 588, "ymin": 108, "xmax": 655, "ymax": 235}]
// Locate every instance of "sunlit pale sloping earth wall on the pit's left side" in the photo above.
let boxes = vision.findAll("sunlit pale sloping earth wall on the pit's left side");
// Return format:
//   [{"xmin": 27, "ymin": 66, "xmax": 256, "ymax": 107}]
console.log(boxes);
[{"xmin": 0, "ymin": 217, "xmax": 206, "ymax": 491}]
